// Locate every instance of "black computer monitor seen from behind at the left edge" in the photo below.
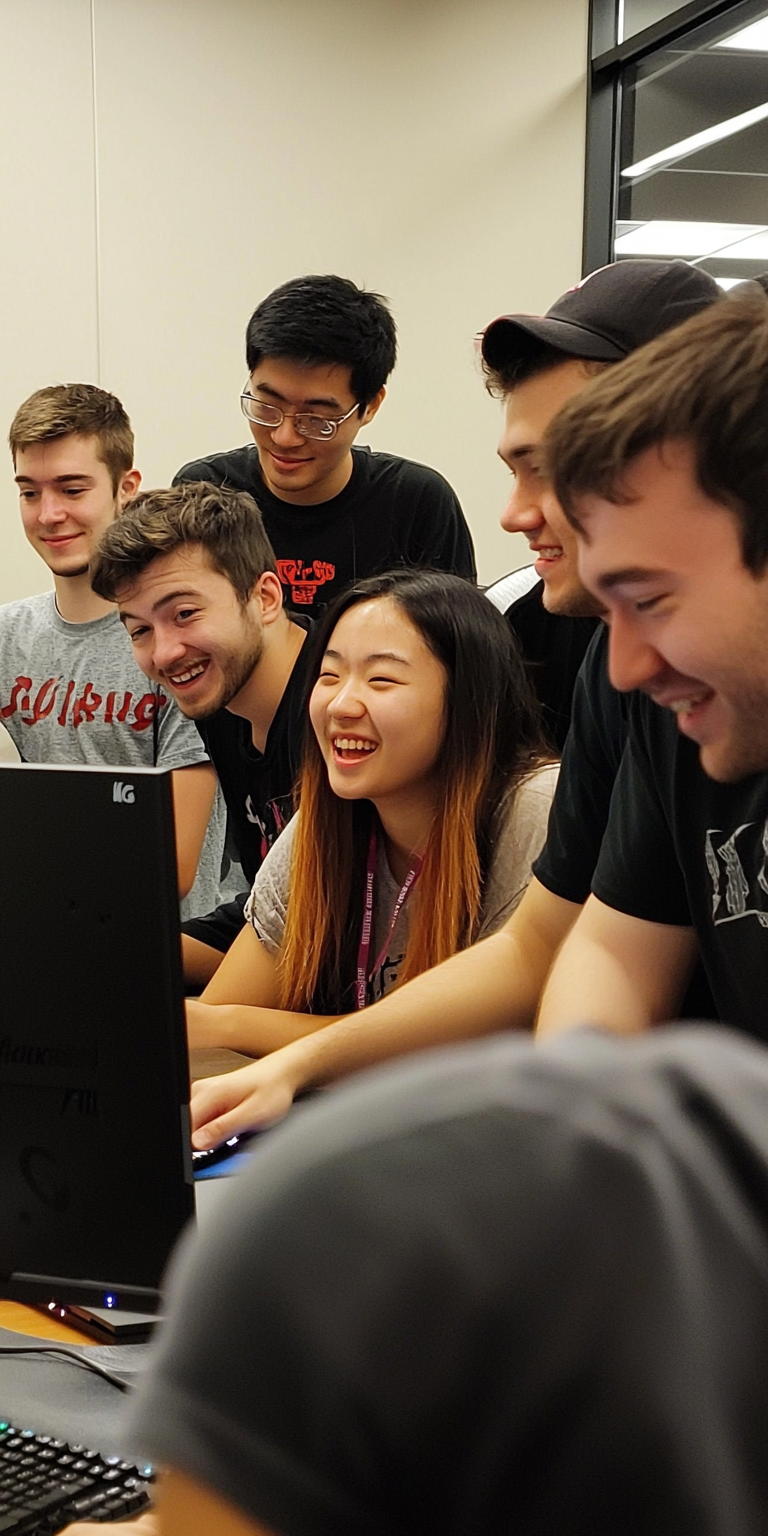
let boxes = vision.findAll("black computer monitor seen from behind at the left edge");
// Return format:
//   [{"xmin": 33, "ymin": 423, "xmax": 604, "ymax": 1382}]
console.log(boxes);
[{"xmin": 0, "ymin": 763, "xmax": 195, "ymax": 1312}]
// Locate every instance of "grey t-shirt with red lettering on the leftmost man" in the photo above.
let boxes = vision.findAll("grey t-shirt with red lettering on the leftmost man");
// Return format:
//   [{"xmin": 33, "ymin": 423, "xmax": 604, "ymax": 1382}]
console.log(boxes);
[{"xmin": 0, "ymin": 591, "xmax": 226, "ymax": 917}]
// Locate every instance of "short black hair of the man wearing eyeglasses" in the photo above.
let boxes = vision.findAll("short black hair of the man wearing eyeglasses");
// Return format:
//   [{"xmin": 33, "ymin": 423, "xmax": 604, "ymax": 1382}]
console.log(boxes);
[{"xmin": 246, "ymin": 275, "xmax": 398, "ymax": 410}]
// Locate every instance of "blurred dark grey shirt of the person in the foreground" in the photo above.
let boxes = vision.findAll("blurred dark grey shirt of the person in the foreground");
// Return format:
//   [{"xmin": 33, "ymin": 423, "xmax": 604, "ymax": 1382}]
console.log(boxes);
[{"xmin": 129, "ymin": 1029, "xmax": 768, "ymax": 1536}]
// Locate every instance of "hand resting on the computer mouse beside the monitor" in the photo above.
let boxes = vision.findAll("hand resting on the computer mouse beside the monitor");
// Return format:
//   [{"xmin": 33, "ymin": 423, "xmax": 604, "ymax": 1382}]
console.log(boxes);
[{"xmin": 190, "ymin": 1046, "xmax": 303, "ymax": 1152}]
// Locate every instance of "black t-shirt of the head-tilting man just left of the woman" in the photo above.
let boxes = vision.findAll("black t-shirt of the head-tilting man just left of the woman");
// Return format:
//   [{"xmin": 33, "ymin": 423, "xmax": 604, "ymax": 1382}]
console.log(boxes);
[{"xmin": 183, "ymin": 614, "xmax": 310, "ymax": 951}]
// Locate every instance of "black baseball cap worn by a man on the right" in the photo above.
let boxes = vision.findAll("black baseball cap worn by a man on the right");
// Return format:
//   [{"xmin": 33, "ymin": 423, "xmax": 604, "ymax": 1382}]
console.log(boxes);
[{"xmin": 481, "ymin": 261, "xmax": 723, "ymax": 372}]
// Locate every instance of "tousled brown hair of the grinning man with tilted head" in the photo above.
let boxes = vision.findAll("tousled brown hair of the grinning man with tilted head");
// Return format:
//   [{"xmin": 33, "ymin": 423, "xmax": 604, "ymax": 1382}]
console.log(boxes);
[{"xmin": 91, "ymin": 481, "xmax": 276, "ymax": 602}]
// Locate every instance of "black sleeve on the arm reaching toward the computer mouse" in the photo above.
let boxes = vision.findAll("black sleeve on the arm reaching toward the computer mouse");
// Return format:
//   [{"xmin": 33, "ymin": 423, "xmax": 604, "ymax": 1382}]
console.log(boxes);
[{"xmin": 533, "ymin": 621, "xmax": 634, "ymax": 906}]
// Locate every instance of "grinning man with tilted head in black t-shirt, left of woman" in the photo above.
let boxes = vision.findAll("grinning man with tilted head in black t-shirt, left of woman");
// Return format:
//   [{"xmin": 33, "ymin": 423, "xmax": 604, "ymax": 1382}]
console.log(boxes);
[{"xmin": 94, "ymin": 484, "xmax": 309, "ymax": 986}]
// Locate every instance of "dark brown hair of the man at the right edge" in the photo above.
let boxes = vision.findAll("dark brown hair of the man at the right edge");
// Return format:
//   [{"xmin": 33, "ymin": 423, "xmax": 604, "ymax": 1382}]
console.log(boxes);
[{"xmin": 547, "ymin": 296, "xmax": 768, "ymax": 571}]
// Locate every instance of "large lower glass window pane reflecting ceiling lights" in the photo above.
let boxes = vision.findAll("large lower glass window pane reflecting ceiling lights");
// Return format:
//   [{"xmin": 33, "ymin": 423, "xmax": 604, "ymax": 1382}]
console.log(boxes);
[{"xmin": 616, "ymin": 5, "xmax": 768, "ymax": 284}]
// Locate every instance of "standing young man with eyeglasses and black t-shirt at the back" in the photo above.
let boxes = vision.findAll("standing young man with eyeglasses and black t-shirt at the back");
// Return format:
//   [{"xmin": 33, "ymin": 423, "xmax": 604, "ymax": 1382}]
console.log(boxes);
[{"xmin": 174, "ymin": 276, "xmax": 476, "ymax": 613}]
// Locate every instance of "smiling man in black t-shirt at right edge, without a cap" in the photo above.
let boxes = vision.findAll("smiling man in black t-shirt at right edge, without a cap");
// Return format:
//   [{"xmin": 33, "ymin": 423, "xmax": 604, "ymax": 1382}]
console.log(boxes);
[{"xmin": 539, "ymin": 298, "xmax": 768, "ymax": 1040}]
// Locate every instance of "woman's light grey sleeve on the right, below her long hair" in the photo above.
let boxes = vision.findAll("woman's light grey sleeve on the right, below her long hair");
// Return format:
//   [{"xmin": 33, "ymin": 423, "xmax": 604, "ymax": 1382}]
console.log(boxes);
[{"xmin": 478, "ymin": 763, "xmax": 559, "ymax": 938}]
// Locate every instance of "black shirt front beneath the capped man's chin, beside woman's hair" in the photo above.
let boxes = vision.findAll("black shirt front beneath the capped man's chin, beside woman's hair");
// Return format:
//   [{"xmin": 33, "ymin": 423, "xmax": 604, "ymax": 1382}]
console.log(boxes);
[{"xmin": 504, "ymin": 568, "xmax": 601, "ymax": 753}]
